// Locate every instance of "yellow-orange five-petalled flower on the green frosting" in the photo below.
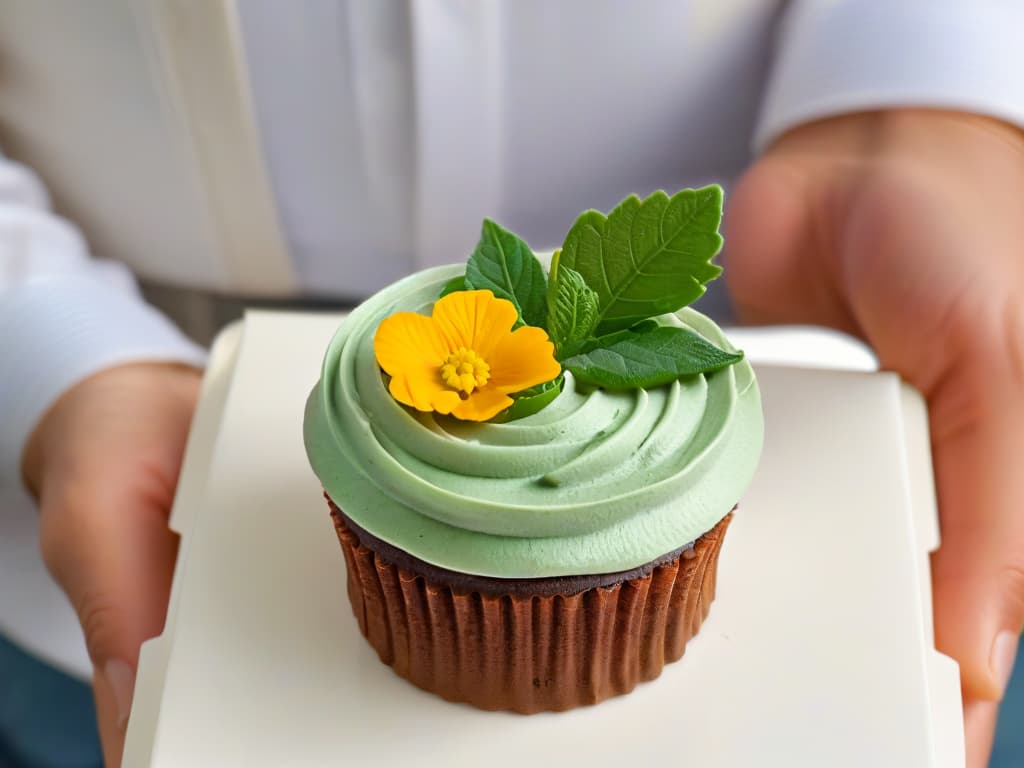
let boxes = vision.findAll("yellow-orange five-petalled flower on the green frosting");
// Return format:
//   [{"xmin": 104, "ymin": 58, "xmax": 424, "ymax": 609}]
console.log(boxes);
[{"xmin": 374, "ymin": 291, "xmax": 562, "ymax": 421}]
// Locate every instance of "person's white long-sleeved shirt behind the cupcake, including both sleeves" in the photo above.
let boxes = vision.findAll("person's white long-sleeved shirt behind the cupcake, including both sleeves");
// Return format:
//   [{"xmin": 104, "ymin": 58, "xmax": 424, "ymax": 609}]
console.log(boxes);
[{"xmin": 6, "ymin": 0, "xmax": 1024, "ymax": 671}]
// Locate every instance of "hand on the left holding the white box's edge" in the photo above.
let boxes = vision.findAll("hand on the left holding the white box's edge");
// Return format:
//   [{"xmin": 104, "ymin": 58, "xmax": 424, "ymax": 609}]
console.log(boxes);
[{"xmin": 23, "ymin": 364, "xmax": 200, "ymax": 766}]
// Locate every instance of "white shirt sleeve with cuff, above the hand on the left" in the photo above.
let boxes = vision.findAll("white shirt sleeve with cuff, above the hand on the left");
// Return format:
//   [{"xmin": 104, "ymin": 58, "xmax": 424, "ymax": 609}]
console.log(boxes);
[{"xmin": 0, "ymin": 155, "xmax": 206, "ymax": 487}]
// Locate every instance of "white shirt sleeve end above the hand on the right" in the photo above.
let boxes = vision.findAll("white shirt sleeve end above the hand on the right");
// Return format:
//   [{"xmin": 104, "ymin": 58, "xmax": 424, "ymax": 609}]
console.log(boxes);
[{"xmin": 753, "ymin": 0, "xmax": 1024, "ymax": 152}]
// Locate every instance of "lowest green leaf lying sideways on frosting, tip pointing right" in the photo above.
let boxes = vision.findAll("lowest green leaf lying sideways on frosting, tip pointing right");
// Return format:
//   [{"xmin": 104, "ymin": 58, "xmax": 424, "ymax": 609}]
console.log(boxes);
[{"xmin": 563, "ymin": 326, "xmax": 743, "ymax": 389}]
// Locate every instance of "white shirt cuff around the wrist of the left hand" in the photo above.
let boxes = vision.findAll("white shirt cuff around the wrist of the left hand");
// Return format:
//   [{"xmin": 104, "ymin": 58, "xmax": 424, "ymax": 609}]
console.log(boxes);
[{"xmin": 0, "ymin": 275, "xmax": 206, "ymax": 486}]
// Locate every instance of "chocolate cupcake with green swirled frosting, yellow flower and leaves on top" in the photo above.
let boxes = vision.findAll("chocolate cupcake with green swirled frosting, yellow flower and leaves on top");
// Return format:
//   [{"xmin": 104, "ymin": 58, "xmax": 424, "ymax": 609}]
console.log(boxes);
[{"xmin": 304, "ymin": 186, "xmax": 763, "ymax": 714}]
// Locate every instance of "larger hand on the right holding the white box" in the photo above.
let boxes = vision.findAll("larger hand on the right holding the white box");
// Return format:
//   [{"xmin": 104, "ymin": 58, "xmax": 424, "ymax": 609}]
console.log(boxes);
[{"xmin": 725, "ymin": 110, "xmax": 1024, "ymax": 766}]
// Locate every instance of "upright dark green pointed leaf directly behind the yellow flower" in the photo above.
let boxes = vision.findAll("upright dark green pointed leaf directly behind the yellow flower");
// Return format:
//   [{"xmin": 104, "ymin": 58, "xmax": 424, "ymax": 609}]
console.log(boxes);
[{"xmin": 466, "ymin": 219, "xmax": 547, "ymax": 328}]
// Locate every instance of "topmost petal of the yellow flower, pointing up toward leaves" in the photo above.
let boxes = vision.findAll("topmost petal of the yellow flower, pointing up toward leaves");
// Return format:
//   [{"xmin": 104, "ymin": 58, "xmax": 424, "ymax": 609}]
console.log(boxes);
[{"xmin": 432, "ymin": 291, "xmax": 519, "ymax": 362}]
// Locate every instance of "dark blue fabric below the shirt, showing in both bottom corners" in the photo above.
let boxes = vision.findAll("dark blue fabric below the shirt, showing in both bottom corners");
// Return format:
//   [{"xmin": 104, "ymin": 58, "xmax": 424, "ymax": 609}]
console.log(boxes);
[{"xmin": 0, "ymin": 636, "xmax": 1024, "ymax": 768}]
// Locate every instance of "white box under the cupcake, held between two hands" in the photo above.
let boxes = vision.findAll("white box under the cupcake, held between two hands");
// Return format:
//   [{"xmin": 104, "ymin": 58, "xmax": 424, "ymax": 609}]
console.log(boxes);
[{"xmin": 124, "ymin": 312, "xmax": 964, "ymax": 768}]
